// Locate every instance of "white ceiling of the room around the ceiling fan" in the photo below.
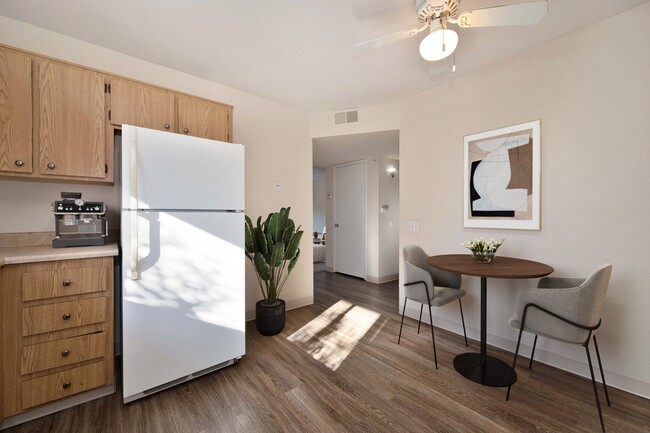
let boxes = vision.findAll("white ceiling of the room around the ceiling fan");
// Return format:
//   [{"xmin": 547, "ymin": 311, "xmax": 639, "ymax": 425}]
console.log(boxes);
[{"xmin": 0, "ymin": 0, "xmax": 648, "ymax": 112}]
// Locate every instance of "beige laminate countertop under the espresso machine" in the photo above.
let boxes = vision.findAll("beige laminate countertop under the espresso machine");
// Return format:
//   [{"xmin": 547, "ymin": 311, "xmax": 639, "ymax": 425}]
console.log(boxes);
[{"xmin": 0, "ymin": 242, "xmax": 119, "ymax": 267}]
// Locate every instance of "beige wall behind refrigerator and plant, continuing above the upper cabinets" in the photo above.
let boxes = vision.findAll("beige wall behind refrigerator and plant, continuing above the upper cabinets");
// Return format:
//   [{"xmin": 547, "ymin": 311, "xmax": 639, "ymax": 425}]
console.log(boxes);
[{"xmin": 0, "ymin": 16, "xmax": 313, "ymax": 318}]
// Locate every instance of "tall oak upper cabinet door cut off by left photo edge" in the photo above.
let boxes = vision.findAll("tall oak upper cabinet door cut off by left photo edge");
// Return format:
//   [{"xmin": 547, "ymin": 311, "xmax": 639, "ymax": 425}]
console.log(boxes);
[{"xmin": 0, "ymin": 47, "xmax": 32, "ymax": 173}]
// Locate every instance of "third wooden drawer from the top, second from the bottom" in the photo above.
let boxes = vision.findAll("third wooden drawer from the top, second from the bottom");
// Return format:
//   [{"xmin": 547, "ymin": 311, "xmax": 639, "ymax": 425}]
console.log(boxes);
[{"xmin": 20, "ymin": 332, "xmax": 106, "ymax": 374}]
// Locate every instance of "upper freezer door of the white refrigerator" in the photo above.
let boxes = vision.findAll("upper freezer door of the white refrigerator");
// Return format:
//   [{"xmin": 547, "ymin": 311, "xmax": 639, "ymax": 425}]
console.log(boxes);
[{"xmin": 122, "ymin": 125, "xmax": 244, "ymax": 210}]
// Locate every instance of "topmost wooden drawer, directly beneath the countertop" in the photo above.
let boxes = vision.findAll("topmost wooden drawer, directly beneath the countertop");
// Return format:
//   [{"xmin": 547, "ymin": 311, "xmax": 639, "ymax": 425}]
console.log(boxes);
[{"xmin": 22, "ymin": 266, "xmax": 111, "ymax": 302}]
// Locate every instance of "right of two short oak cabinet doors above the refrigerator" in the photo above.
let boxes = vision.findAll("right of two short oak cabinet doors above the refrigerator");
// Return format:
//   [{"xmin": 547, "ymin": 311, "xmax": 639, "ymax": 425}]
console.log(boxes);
[{"xmin": 178, "ymin": 95, "xmax": 232, "ymax": 141}]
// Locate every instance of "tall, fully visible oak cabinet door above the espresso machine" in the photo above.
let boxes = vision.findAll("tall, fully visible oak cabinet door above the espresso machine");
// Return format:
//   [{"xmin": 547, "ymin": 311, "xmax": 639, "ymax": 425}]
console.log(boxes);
[{"xmin": 37, "ymin": 60, "xmax": 107, "ymax": 179}]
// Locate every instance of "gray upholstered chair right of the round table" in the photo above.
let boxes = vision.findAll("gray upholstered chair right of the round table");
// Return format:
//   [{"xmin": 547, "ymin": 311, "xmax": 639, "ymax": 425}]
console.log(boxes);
[{"xmin": 506, "ymin": 263, "xmax": 612, "ymax": 432}]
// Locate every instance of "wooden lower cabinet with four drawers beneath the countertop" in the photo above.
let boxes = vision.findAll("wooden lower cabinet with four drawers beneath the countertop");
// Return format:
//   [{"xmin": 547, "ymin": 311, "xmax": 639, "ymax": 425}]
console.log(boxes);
[{"xmin": 0, "ymin": 257, "xmax": 114, "ymax": 421}]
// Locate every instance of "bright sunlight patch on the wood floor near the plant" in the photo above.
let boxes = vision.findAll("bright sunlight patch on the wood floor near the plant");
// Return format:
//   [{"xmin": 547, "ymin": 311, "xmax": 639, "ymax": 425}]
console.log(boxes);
[{"xmin": 287, "ymin": 300, "xmax": 381, "ymax": 371}]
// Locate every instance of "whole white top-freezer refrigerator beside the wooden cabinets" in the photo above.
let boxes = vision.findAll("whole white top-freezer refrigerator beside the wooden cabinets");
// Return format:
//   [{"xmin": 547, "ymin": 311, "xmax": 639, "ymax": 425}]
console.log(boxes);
[{"xmin": 121, "ymin": 125, "xmax": 245, "ymax": 403}]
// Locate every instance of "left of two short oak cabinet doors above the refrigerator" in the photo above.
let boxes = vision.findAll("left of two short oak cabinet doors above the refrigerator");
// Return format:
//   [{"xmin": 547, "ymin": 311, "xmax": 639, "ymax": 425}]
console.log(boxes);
[{"xmin": 111, "ymin": 78, "xmax": 176, "ymax": 132}]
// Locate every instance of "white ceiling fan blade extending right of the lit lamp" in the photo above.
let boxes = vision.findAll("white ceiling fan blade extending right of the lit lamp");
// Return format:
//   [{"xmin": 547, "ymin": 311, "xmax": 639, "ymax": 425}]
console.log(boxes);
[{"xmin": 458, "ymin": 0, "xmax": 548, "ymax": 28}]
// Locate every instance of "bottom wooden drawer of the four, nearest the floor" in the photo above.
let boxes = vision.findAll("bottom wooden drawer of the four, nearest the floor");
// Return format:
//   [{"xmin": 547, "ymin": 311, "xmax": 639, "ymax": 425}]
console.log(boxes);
[{"xmin": 22, "ymin": 361, "xmax": 106, "ymax": 409}]
